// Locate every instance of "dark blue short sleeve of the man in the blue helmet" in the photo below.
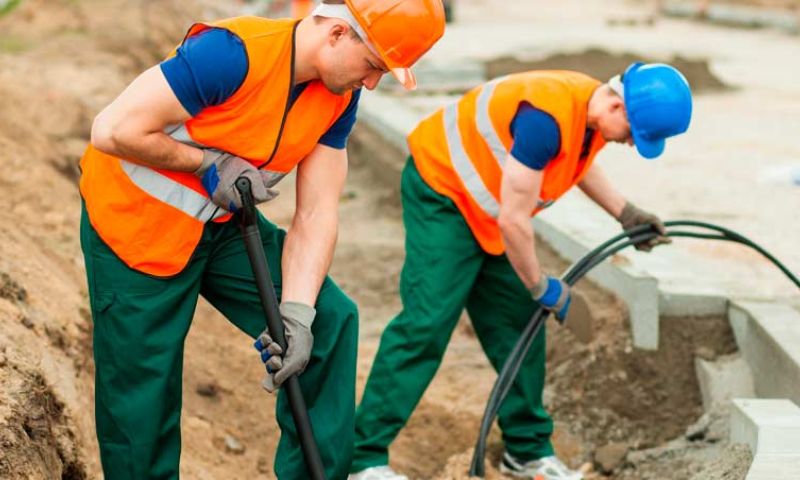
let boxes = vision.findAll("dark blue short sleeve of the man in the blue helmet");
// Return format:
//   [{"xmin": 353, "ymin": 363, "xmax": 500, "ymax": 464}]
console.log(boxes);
[{"xmin": 511, "ymin": 103, "xmax": 561, "ymax": 170}]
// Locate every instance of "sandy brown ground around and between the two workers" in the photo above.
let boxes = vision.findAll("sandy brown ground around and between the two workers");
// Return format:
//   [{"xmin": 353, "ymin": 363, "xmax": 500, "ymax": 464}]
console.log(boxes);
[{"xmin": 0, "ymin": 0, "xmax": 764, "ymax": 480}]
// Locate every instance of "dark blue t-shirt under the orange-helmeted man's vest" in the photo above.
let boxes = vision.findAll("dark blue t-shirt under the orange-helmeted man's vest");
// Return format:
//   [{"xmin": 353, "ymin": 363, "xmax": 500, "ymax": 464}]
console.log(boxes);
[{"xmin": 161, "ymin": 28, "xmax": 361, "ymax": 149}]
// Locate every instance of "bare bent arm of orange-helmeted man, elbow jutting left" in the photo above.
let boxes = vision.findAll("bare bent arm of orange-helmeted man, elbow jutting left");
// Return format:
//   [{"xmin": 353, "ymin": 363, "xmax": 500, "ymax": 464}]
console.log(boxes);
[{"xmin": 92, "ymin": 65, "xmax": 203, "ymax": 172}]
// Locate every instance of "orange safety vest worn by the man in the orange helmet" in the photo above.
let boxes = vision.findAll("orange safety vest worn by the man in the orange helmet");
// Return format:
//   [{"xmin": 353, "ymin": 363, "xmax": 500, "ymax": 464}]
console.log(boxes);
[{"xmin": 80, "ymin": 17, "xmax": 351, "ymax": 277}]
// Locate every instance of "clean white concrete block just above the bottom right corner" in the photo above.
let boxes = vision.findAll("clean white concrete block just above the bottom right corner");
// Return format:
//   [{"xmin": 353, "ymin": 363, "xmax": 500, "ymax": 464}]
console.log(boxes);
[{"xmin": 731, "ymin": 399, "xmax": 800, "ymax": 456}]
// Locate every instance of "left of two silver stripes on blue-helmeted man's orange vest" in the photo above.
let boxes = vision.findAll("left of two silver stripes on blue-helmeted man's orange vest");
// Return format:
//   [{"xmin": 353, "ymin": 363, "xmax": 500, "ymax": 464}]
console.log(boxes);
[{"xmin": 443, "ymin": 103, "xmax": 500, "ymax": 218}]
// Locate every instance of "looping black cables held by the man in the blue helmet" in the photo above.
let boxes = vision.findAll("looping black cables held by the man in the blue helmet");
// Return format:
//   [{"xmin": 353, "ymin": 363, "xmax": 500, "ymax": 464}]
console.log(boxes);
[{"xmin": 469, "ymin": 220, "xmax": 800, "ymax": 477}]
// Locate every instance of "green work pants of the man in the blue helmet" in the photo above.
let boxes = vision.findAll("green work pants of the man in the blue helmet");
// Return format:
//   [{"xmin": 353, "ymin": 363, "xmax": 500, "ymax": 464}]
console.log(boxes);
[{"xmin": 350, "ymin": 159, "xmax": 553, "ymax": 472}]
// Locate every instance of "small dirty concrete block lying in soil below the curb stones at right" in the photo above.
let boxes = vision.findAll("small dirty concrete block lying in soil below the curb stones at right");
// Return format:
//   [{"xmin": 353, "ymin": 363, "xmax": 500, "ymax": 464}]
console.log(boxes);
[{"xmin": 694, "ymin": 354, "xmax": 755, "ymax": 411}]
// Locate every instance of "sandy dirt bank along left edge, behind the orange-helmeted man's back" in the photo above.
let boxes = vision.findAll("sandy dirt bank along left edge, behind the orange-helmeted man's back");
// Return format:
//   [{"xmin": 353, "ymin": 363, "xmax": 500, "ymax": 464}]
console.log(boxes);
[{"xmin": 0, "ymin": 0, "xmax": 231, "ymax": 480}]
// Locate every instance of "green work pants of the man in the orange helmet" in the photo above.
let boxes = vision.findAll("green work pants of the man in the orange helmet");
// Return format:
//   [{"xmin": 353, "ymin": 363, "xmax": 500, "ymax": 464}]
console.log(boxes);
[{"xmin": 81, "ymin": 203, "xmax": 358, "ymax": 480}]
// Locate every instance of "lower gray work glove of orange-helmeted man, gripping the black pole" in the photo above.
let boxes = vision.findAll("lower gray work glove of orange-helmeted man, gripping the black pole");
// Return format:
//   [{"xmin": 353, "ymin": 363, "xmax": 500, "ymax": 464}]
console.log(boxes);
[{"xmin": 255, "ymin": 302, "xmax": 317, "ymax": 393}]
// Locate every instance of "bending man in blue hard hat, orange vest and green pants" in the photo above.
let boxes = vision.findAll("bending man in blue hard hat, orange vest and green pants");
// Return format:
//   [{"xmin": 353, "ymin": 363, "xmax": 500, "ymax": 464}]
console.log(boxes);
[{"xmin": 350, "ymin": 63, "xmax": 692, "ymax": 480}]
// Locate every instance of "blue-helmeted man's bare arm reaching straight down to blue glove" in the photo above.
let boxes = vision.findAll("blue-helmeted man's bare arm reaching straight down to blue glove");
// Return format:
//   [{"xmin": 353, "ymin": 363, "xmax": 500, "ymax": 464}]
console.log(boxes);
[{"xmin": 498, "ymin": 155, "xmax": 543, "ymax": 289}]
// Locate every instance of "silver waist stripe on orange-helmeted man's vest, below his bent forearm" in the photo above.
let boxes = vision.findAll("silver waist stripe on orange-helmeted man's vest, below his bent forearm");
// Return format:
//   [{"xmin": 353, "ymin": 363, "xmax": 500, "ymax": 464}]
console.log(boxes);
[{"xmin": 120, "ymin": 160, "xmax": 228, "ymax": 223}]
